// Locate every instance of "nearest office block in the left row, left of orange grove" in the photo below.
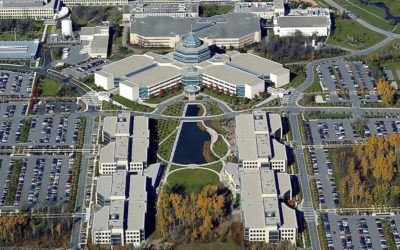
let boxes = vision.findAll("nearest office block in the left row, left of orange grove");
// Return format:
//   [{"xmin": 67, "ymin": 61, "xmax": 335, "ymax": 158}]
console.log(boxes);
[{"xmin": 92, "ymin": 170, "xmax": 147, "ymax": 247}]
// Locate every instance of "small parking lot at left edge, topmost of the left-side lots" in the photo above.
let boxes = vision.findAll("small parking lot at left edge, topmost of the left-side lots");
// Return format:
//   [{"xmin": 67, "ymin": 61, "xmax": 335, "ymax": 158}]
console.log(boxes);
[{"xmin": 0, "ymin": 70, "xmax": 33, "ymax": 96}]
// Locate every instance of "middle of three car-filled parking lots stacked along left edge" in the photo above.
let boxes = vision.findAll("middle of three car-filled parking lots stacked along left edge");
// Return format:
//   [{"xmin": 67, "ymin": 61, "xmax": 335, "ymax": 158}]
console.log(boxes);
[{"xmin": 0, "ymin": 102, "xmax": 80, "ymax": 146}]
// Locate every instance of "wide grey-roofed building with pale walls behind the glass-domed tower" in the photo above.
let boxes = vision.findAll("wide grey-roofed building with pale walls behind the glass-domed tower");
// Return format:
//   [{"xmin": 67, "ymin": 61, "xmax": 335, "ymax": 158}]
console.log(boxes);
[{"xmin": 130, "ymin": 13, "xmax": 261, "ymax": 48}]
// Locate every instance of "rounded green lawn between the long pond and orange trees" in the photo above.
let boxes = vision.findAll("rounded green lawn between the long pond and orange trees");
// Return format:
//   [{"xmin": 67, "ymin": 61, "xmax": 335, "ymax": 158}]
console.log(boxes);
[{"xmin": 167, "ymin": 169, "xmax": 219, "ymax": 194}]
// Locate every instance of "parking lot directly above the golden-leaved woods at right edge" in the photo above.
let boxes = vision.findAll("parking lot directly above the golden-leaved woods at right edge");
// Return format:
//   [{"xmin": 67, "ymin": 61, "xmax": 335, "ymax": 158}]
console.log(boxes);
[{"xmin": 305, "ymin": 118, "xmax": 400, "ymax": 145}]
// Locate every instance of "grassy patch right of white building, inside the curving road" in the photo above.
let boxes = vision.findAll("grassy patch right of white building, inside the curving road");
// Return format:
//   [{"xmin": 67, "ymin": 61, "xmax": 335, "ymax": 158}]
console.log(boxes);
[{"xmin": 327, "ymin": 18, "xmax": 385, "ymax": 49}]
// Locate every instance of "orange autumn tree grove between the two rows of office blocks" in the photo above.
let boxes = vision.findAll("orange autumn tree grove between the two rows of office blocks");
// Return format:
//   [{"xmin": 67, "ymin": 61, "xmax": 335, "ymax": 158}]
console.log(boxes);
[{"xmin": 157, "ymin": 185, "xmax": 232, "ymax": 242}]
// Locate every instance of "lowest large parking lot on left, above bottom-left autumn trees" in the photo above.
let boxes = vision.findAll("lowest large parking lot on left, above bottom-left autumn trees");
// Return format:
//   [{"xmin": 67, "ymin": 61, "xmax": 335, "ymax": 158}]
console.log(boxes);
[{"xmin": 0, "ymin": 155, "xmax": 74, "ymax": 207}]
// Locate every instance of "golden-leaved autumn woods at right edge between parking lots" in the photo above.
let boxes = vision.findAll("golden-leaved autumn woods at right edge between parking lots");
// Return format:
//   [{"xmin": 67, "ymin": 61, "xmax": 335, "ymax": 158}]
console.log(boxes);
[{"xmin": 331, "ymin": 134, "xmax": 400, "ymax": 207}]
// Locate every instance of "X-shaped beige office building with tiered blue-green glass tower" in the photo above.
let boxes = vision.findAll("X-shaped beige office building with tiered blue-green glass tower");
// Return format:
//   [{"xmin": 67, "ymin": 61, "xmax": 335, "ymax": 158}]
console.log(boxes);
[{"xmin": 95, "ymin": 33, "xmax": 290, "ymax": 101}]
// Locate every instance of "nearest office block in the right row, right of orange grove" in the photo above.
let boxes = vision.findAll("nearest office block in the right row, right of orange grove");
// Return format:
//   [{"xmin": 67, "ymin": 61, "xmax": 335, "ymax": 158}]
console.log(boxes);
[{"xmin": 240, "ymin": 168, "xmax": 298, "ymax": 244}]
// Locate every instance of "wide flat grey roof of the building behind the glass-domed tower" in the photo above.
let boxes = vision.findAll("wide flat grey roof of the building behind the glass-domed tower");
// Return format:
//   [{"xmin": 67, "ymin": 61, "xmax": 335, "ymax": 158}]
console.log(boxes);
[{"xmin": 131, "ymin": 13, "xmax": 260, "ymax": 38}]
